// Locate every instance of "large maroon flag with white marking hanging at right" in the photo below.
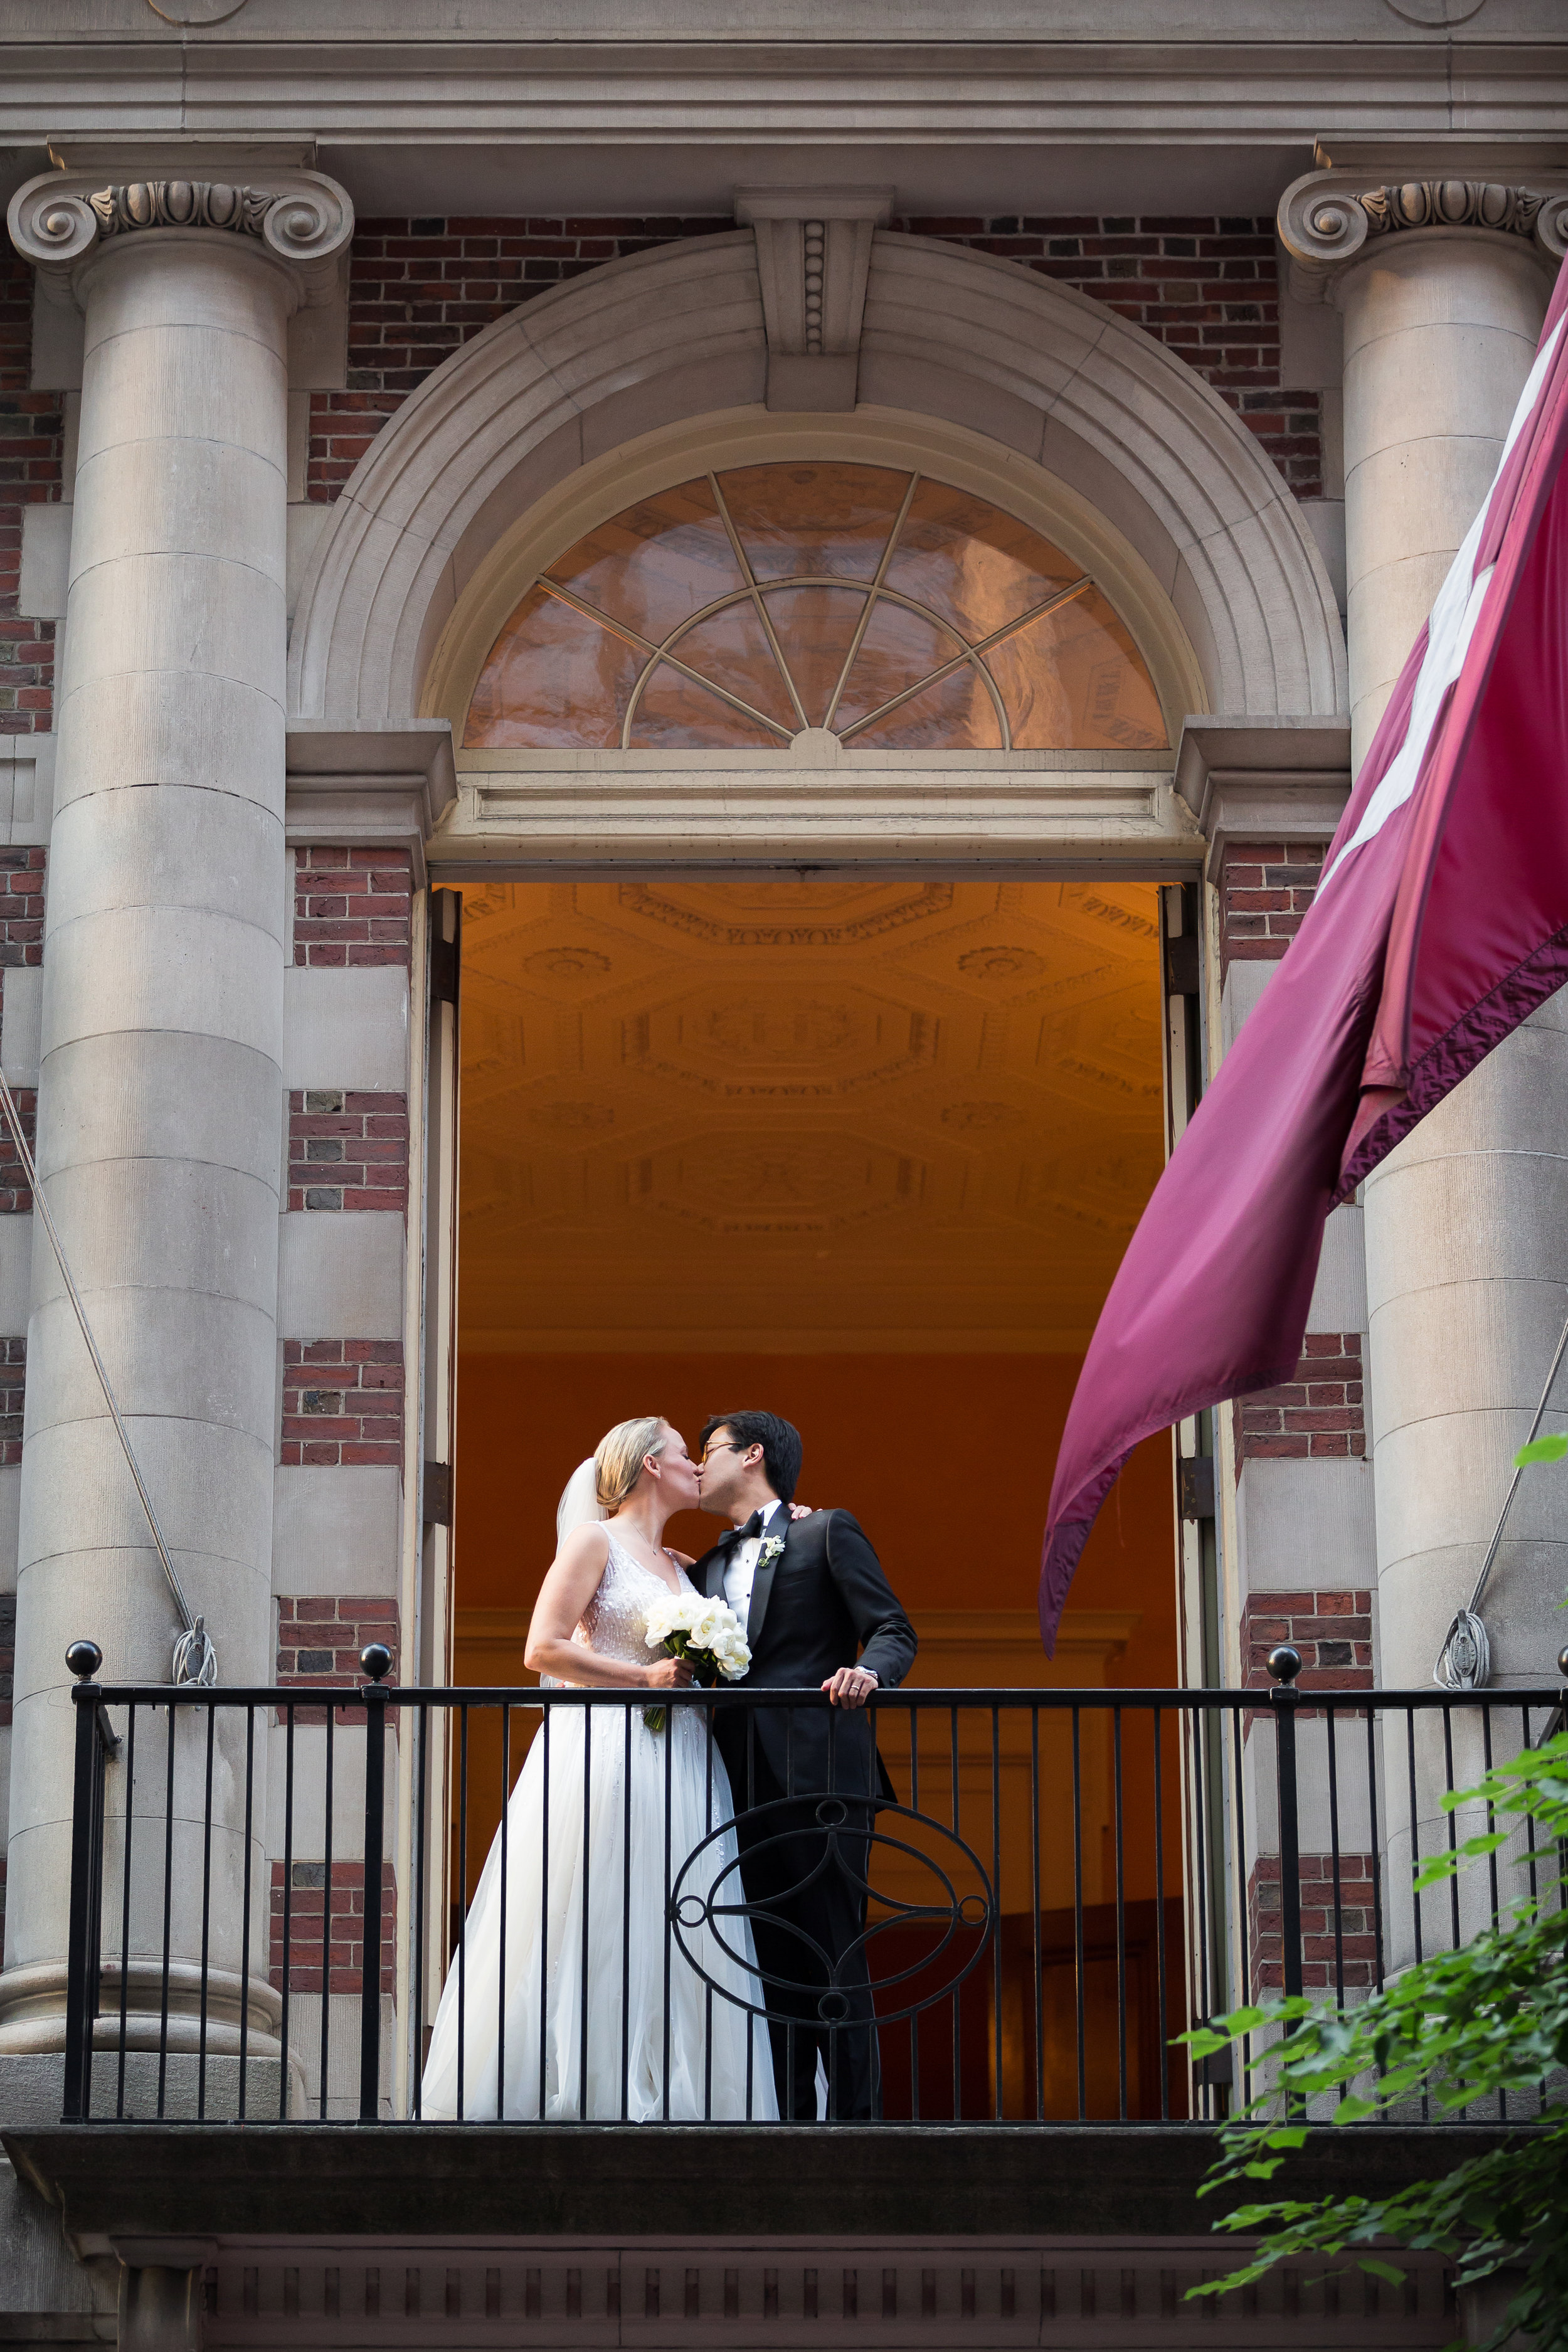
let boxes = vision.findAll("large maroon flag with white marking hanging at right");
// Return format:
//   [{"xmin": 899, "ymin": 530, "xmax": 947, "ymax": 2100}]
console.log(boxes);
[{"xmin": 1039, "ymin": 263, "xmax": 1568, "ymax": 1649}]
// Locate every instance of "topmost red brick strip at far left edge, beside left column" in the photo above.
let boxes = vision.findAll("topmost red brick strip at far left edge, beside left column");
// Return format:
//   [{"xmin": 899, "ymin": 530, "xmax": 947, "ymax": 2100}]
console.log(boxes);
[{"xmin": 0, "ymin": 245, "xmax": 66, "ymax": 734}]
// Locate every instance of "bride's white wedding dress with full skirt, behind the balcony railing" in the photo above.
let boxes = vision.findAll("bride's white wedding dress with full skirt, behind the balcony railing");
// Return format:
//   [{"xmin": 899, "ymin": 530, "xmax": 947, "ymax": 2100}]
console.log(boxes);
[{"xmin": 421, "ymin": 1529, "xmax": 778, "ymax": 2124}]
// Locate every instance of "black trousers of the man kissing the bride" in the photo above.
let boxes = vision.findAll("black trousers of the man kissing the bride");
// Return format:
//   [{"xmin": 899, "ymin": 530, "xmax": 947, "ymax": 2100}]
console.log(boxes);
[{"xmin": 736, "ymin": 1750, "xmax": 882, "ymax": 2122}]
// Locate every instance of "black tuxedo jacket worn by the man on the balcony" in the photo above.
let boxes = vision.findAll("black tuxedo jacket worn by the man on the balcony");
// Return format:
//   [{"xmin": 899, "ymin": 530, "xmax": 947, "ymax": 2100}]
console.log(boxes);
[{"xmin": 691, "ymin": 1510, "xmax": 917, "ymax": 1811}]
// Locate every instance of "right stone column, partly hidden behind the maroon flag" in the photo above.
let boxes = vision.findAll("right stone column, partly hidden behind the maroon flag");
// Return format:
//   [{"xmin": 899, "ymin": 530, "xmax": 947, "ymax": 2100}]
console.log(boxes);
[{"xmin": 1281, "ymin": 172, "xmax": 1568, "ymax": 1957}]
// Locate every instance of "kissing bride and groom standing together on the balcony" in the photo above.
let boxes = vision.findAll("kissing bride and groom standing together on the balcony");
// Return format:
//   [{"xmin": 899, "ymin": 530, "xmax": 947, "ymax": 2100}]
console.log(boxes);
[{"xmin": 421, "ymin": 1414, "xmax": 914, "ymax": 2124}]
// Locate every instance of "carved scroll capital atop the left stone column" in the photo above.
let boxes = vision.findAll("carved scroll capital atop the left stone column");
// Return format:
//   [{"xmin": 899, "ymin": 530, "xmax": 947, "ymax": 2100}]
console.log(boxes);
[{"xmin": 7, "ymin": 169, "xmax": 355, "ymax": 308}]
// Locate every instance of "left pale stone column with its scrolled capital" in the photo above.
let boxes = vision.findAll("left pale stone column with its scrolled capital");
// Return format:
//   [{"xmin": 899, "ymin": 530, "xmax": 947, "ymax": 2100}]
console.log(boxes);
[{"xmin": 0, "ymin": 172, "xmax": 352, "ymax": 2051}]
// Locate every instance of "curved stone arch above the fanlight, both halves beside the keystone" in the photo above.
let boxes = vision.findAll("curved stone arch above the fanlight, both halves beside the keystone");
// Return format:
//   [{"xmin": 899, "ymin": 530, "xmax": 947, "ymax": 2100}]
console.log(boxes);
[{"xmin": 289, "ymin": 231, "xmax": 1345, "ymax": 727}]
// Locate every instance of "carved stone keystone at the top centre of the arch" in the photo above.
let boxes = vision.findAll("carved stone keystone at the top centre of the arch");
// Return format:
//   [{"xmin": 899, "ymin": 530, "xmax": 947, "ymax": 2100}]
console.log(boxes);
[{"xmin": 736, "ymin": 188, "xmax": 893, "ymax": 411}]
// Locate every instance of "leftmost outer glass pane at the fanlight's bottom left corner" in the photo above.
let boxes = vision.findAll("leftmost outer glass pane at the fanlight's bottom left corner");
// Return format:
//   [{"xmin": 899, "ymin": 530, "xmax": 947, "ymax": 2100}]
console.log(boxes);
[{"xmin": 463, "ymin": 588, "xmax": 644, "ymax": 750}]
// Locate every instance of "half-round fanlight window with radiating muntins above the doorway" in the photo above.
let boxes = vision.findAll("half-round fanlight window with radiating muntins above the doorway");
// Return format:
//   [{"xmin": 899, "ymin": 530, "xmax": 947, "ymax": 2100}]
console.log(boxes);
[{"xmin": 463, "ymin": 464, "xmax": 1166, "ymax": 750}]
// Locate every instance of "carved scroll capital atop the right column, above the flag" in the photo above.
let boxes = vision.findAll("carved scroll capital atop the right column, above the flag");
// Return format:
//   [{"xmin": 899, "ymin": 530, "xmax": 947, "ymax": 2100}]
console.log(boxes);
[{"xmin": 1279, "ymin": 169, "xmax": 1568, "ymax": 301}]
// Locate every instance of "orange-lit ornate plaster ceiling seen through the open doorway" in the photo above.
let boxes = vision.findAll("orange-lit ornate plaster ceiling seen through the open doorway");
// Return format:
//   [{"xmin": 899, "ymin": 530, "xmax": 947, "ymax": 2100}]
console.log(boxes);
[{"xmin": 461, "ymin": 875, "xmax": 1162, "ymax": 1352}]
